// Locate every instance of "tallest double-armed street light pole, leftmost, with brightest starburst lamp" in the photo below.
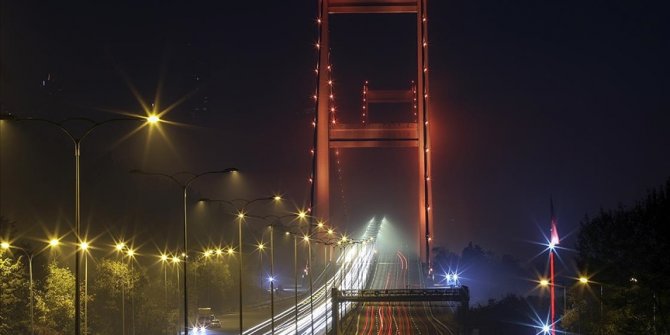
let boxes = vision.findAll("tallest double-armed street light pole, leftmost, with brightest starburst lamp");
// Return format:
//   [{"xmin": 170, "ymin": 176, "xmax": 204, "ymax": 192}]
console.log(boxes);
[{"xmin": 0, "ymin": 114, "xmax": 160, "ymax": 335}]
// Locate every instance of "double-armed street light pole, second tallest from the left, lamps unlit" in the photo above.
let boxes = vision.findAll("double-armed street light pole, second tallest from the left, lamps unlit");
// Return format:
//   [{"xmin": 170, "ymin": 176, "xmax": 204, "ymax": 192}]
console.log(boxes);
[{"xmin": 130, "ymin": 168, "xmax": 239, "ymax": 335}]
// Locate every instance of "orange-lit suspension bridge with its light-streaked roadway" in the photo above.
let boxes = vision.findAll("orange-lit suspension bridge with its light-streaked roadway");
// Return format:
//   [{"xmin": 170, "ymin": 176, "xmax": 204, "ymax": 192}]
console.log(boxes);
[{"xmin": 231, "ymin": 0, "xmax": 469, "ymax": 335}]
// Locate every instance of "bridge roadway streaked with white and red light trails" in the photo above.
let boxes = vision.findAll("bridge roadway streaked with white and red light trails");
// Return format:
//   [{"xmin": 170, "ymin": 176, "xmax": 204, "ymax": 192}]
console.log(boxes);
[{"xmin": 234, "ymin": 219, "xmax": 458, "ymax": 335}]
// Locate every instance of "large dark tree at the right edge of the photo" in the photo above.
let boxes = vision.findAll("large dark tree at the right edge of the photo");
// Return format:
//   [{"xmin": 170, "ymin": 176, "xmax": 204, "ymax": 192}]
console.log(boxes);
[{"xmin": 569, "ymin": 180, "xmax": 670, "ymax": 334}]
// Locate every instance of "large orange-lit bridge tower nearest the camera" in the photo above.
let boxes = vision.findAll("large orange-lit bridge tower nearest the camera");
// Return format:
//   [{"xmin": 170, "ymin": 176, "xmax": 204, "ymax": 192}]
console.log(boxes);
[{"xmin": 314, "ymin": 0, "xmax": 433, "ymax": 265}]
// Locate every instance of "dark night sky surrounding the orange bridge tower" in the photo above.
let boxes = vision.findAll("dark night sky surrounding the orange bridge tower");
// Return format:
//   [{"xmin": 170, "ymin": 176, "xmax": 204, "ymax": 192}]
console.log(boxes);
[{"xmin": 0, "ymin": 0, "xmax": 670, "ymax": 259}]
